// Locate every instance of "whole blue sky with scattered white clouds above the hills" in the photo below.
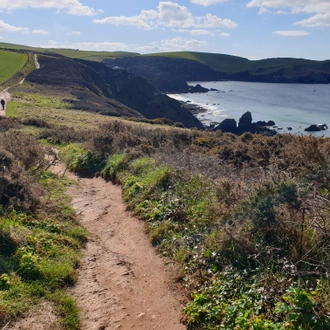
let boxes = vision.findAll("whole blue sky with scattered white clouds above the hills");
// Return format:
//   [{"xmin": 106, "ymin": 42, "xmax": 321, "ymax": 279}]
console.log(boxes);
[{"xmin": 0, "ymin": 0, "xmax": 330, "ymax": 60}]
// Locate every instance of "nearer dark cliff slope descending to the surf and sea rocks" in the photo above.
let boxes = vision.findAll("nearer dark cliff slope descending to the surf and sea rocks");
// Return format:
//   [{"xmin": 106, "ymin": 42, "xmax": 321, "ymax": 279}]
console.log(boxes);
[{"xmin": 26, "ymin": 55, "xmax": 203, "ymax": 128}]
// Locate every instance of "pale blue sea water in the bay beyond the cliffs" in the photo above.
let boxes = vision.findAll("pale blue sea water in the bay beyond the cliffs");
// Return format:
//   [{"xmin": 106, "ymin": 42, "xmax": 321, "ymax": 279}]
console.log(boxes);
[{"xmin": 168, "ymin": 81, "xmax": 330, "ymax": 137}]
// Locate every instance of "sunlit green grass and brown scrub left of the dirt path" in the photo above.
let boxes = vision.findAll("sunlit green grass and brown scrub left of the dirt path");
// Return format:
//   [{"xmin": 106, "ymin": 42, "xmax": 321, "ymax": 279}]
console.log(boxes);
[{"xmin": 0, "ymin": 127, "xmax": 87, "ymax": 329}]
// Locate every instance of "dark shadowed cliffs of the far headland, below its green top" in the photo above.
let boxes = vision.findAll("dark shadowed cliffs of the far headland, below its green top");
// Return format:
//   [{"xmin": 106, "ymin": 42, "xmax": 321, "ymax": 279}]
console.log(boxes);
[{"xmin": 104, "ymin": 55, "xmax": 330, "ymax": 93}]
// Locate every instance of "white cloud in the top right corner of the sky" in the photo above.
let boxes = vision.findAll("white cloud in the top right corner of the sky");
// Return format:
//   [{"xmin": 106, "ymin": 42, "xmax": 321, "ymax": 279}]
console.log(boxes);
[{"xmin": 247, "ymin": 0, "xmax": 330, "ymax": 27}]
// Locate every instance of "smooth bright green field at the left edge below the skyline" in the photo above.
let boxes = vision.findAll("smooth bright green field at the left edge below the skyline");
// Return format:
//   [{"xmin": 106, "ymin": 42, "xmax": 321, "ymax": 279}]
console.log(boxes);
[{"xmin": 0, "ymin": 50, "xmax": 28, "ymax": 84}]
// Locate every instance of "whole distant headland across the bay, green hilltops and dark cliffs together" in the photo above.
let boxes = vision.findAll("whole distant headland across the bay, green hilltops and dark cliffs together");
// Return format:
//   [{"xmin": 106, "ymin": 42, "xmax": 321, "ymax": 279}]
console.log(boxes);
[{"xmin": 0, "ymin": 43, "xmax": 330, "ymax": 93}]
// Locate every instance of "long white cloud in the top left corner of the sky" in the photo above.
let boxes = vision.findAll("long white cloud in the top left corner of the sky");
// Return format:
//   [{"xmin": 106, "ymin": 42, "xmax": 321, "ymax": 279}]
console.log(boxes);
[{"xmin": 0, "ymin": 0, "xmax": 102, "ymax": 16}]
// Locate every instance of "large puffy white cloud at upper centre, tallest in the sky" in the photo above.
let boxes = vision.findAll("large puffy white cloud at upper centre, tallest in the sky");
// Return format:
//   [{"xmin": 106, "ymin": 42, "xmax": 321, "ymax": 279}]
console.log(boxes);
[{"xmin": 93, "ymin": 1, "xmax": 238, "ymax": 30}]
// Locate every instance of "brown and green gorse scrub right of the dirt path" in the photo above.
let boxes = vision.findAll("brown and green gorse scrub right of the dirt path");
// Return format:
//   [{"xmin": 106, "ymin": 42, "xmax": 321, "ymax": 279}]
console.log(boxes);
[{"xmin": 42, "ymin": 121, "xmax": 330, "ymax": 329}]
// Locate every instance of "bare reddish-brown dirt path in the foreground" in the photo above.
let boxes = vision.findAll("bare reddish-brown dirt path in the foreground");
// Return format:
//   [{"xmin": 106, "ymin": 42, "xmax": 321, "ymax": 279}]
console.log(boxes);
[{"xmin": 51, "ymin": 165, "xmax": 186, "ymax": 330}]
